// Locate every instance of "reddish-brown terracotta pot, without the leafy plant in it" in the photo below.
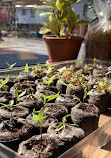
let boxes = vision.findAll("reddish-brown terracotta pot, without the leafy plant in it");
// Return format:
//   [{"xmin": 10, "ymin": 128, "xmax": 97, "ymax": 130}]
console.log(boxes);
[{"xmin": 43, "ymin": 36, "xmax": 83, "ymax": 63}]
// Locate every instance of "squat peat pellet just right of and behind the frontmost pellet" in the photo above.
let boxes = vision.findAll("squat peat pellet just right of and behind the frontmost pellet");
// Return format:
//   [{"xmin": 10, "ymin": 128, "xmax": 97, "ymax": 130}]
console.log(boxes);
[{"xmin": 47, "ymin": 122, "xmax": 85, "ymax": 152}]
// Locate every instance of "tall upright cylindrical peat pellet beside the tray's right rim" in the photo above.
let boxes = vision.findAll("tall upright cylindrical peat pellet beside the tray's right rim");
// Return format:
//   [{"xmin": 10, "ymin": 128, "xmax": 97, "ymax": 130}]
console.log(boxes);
[{"xmin": 71, "ymin": 103, "xmax": 99, "ymax": 136}]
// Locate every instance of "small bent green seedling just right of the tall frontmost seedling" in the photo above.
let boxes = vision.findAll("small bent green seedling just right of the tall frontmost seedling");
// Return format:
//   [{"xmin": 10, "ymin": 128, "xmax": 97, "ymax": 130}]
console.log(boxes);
[{"xmin": 55, "ymin": 114, "xmax": 71, "ymax": 132}]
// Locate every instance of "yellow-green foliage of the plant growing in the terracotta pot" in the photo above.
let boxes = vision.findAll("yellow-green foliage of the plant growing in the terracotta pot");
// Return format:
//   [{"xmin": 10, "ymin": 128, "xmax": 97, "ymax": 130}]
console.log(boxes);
[{"xmin": 37, "ymin": 0, "xmax": 88, "ymax": 38}]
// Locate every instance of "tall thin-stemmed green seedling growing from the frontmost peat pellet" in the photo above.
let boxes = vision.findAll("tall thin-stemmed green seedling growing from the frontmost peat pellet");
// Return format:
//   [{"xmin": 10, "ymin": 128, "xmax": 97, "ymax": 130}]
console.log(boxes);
[{"xmin": 32, "ymin": 106, "xmax": 46, "ymax": 146}]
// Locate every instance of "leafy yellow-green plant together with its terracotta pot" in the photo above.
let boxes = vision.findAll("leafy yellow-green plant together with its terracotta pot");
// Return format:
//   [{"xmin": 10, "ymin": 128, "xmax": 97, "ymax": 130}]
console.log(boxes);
[{"xmin": 37, "ymin": 0, "xmax": 88, "ymax": 63}]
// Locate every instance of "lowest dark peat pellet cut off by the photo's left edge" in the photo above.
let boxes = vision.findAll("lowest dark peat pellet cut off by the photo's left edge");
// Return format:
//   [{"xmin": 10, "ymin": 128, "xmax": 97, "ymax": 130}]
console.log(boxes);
[{"xmin": 0, "ymin": 118, "xmax": 32, "ymax": 151}]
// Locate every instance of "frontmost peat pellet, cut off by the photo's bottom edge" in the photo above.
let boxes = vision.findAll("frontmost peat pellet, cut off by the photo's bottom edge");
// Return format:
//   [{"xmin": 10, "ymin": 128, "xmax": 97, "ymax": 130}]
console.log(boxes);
[{"xmin": 18, "ymin": 134, "xmax": 60, "ymax": 158}]
